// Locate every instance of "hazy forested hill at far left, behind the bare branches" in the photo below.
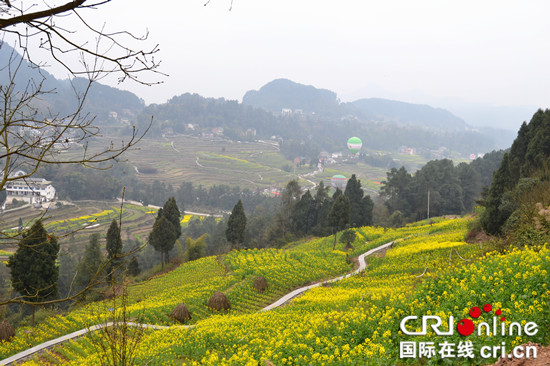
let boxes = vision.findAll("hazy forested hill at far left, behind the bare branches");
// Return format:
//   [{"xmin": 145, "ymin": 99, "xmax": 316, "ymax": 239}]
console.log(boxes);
[{"xmin": 0, "ymin": 42, "xmax": 145, "ymax": 124}]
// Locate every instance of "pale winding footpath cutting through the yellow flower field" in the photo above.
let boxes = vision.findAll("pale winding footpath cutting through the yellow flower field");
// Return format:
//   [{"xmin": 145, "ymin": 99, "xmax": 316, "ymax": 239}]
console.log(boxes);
[{"xmin": 0, "ymin": 241, "xmax": 394, "ymax": 365}]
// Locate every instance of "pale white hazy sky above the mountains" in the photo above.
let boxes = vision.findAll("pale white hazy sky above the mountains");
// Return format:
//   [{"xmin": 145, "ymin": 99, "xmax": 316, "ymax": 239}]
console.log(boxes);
[{"xmin": 46, "ymin": 0, "xmax": 550, "ymax": 107}]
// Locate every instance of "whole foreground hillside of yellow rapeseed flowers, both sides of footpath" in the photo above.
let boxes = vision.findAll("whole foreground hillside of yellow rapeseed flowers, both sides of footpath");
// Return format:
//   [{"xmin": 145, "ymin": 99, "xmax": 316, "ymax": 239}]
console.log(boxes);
[{"xmin": 0, "ymin": 219, "xmax": 550, "ymax": 365}]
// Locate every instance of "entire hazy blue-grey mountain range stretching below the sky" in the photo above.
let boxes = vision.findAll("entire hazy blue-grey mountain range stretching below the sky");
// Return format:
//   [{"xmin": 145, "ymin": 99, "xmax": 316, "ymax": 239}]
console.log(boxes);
[{"xmin": 0, "ymin": 43, "xmax": 509, "ymax": 153}]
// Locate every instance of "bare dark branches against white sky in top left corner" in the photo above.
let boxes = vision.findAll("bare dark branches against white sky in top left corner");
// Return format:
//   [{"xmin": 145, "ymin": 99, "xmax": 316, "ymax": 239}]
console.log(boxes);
[{"xmin": 0, "ymin": 0, "xmax": 165, "ymax": 85}]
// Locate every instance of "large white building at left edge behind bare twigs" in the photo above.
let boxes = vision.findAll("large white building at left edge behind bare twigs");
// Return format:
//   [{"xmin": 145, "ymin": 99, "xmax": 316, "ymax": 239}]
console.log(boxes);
[{"xmin": 6, "ymin": 170, "xmax": 55, "ymax": 204}]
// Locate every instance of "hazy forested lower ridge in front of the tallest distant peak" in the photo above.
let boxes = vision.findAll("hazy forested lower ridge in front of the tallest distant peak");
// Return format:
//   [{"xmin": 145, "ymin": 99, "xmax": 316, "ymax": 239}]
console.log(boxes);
[{"xmin": 138, "ymin": 93, "xmax": 504, "ymax": 157}]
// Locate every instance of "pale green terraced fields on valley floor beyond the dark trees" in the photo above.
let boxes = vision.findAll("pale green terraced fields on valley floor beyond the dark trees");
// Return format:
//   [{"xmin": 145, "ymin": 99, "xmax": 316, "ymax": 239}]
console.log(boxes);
[{"xmin": 69, "ymin": 135, "xmax": 436, "ymax": 193}]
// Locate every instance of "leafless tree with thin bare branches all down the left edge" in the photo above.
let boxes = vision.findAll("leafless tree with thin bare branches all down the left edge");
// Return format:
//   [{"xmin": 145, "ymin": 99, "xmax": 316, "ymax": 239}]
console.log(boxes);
[{"xmin": 0, "ymin": 0, "xmax": 164, "ymax": 305}]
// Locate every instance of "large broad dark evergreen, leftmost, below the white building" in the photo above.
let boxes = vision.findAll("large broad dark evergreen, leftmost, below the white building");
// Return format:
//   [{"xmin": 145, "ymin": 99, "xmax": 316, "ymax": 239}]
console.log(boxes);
[{"xmin": 8, "ymin": 220, "xmax": 59, "ymax": 324}]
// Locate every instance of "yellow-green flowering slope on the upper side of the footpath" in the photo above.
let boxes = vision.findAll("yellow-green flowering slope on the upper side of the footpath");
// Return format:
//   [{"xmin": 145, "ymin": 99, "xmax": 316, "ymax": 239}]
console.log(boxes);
[{"xmin": 0, "ymin": 220, "xmax": 412, "ymax": 357}]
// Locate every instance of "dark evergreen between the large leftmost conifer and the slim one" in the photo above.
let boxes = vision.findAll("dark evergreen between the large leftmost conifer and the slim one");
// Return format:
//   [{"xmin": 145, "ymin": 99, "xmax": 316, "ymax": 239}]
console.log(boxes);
[{"xmin": 75, "ymin": 233, "xmax": 105, "ymax": 290}]
